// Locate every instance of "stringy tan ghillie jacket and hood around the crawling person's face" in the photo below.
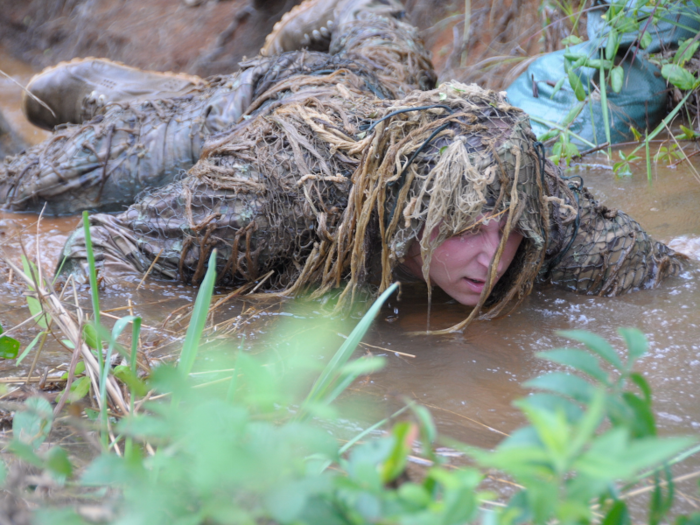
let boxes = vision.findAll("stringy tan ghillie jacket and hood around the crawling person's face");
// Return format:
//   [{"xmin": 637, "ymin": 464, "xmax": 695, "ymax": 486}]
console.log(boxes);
[{"xmin": 58, "ymin": 80, "xmax": 680, "ymax": 330}]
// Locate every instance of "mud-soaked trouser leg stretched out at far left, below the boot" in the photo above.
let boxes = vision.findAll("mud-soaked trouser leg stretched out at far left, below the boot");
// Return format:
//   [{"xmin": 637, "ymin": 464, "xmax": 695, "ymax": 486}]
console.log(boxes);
[{"xmin": 0, "ymin": 67, "xmax": 263, "ymax": 215}]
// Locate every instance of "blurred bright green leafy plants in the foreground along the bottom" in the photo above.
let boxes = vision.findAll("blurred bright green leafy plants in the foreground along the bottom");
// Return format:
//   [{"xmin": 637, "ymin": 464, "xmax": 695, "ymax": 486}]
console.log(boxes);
[{"xmin": 6, "ymin": 316, "xmax": 698, "ymax": 525}]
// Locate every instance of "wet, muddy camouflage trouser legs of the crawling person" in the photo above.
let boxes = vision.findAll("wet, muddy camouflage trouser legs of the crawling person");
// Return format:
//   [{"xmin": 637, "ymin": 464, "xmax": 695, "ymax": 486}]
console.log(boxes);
[{"xmin": 0, "ymin": 0, "xmax": 436, "ymax": 215}]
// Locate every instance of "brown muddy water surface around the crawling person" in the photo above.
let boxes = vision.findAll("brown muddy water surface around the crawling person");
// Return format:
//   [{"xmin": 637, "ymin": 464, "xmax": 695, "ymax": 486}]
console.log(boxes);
[{"xmin": 0, "ymin": 52, "xmax": 700, "ymax": 510}]
